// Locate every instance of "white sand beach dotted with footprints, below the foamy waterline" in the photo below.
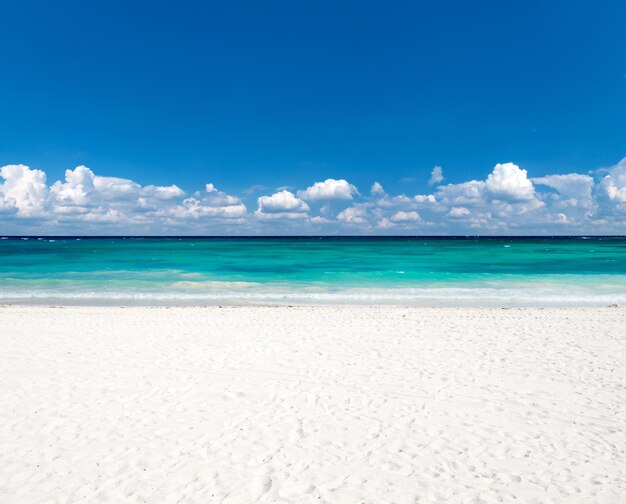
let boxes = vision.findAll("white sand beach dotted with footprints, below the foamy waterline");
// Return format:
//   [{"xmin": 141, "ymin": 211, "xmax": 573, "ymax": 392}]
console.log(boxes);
[{"xmin": 0, "ymin": 306, "xmax": 626, "ymax": 504}]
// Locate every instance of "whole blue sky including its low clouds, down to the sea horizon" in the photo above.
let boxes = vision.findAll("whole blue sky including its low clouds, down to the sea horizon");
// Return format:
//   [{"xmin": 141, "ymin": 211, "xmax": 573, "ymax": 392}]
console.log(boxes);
[{"xmin": 0, "ymin": 1, "xmax": 626, "ymax": 234}]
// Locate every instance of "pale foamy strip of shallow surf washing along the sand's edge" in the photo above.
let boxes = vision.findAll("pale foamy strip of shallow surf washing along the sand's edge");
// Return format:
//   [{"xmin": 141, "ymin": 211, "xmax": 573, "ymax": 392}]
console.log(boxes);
[{"xmin": 0, "ymin": 282, "xmax": 626, "ymax": 307}]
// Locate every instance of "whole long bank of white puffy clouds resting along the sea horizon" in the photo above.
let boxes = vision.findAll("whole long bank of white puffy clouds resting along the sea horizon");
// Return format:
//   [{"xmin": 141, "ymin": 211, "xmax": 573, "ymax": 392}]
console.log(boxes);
[{"xmin": 0, "ymin": 158, "xmax": 626, "ymax": 235}]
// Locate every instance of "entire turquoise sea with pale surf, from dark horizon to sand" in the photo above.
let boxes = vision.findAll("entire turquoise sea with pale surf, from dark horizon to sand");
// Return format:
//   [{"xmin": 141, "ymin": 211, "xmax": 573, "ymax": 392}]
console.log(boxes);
[{"xmin": 0, "ymin": 237, "xmax": 626, "ymax": 306}]
